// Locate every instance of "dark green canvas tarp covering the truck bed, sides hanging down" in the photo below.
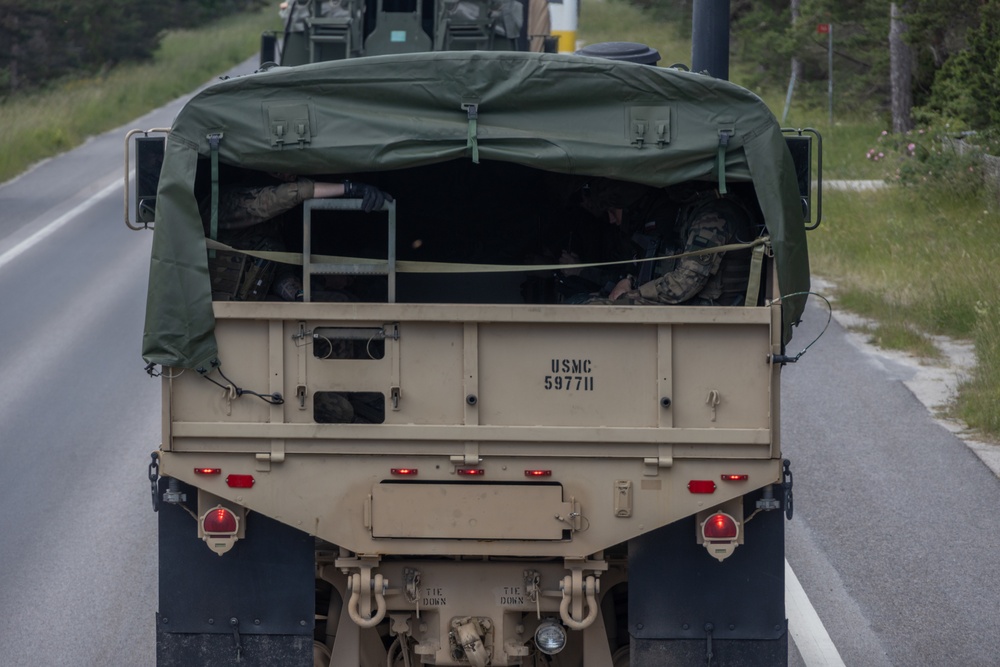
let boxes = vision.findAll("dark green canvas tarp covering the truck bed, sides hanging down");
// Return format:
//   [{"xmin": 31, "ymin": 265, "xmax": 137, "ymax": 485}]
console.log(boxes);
[{"xmin": 143, "ymin": 52, "xmax": 809, "ymax": 368}]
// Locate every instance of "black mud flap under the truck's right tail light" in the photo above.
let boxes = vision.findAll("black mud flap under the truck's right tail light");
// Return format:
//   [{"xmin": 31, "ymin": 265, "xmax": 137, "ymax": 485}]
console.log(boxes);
[{"xmin": 629, "ymin": 494, "xmax": 788, "ymax": 667}]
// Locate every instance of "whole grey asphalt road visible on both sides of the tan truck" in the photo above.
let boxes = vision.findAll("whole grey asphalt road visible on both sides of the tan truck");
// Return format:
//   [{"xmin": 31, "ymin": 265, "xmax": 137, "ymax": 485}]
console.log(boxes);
[{"xmin": 0, "ymin": 64, "xmax": 1000, "ymax": 667}]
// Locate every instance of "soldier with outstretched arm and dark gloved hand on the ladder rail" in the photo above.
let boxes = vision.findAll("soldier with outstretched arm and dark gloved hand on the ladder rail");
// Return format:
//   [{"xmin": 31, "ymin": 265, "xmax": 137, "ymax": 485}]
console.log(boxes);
[{"xmin": 201, "ymin": 174, "xmax": 392, "ymax": 301}]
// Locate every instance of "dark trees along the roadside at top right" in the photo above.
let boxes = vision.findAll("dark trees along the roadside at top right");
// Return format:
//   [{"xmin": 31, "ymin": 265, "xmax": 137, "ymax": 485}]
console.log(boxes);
[{"xmin": 633, "ymin": 0, "xmax": 1000, "ymax": 130}]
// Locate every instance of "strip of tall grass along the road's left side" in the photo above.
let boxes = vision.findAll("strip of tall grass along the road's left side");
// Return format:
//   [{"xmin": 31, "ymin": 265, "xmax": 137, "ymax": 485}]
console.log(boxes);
[{"xmin": 0, "ymin": 6, "xmax": 279, "ymax": 182}]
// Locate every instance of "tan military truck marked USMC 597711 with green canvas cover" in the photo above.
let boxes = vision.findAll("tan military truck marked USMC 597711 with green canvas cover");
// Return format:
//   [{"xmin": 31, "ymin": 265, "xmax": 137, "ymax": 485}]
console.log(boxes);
[{"xmin": 126, "ymin": 51, "xmax": 810, "ymax": 667}]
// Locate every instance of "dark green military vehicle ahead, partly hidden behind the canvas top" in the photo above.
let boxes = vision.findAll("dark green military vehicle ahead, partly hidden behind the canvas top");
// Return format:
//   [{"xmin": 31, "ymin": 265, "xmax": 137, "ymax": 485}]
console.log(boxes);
[{"xmin": 260, "ymin": 0, "xmax": 556, "ymax": 66}]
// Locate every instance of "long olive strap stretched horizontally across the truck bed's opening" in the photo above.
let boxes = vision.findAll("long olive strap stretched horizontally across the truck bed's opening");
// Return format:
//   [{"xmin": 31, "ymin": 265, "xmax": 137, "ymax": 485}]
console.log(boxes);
[{"xmin": 199, "ymin": 236, "xmax": 771, "ymax": 273}]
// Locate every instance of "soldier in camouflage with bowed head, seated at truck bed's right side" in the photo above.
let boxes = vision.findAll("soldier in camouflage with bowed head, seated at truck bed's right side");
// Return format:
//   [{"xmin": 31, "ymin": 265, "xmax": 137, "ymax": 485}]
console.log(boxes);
[{"xmin": 583, "ymin": 182, "xmax": 755, "ymax": 306}]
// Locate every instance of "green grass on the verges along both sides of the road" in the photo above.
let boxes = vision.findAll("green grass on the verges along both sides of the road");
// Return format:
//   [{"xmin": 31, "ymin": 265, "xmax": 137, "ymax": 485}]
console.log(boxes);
[{"xmin": 0, "ymin": 0, "xmax": 1000, "ymax": 437}]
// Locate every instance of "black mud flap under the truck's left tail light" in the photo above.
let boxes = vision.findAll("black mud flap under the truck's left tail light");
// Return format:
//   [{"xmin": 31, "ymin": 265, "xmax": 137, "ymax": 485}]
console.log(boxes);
[{"xmin": 156, "ymin": 479, "xmax": 315, "ymax": 667}]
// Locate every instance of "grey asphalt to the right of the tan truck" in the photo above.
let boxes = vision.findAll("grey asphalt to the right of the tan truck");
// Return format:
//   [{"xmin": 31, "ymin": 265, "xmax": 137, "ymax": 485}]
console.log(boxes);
[{"xmin": 782, "ymin": 298, "xmax": 1000, "ymax": 667}]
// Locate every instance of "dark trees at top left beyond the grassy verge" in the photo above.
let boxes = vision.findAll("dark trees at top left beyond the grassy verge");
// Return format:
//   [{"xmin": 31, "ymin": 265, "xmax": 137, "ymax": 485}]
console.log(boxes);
[{"xmin": 0, "ymin": 0, "xmax": 265, "ymax": 95}]
